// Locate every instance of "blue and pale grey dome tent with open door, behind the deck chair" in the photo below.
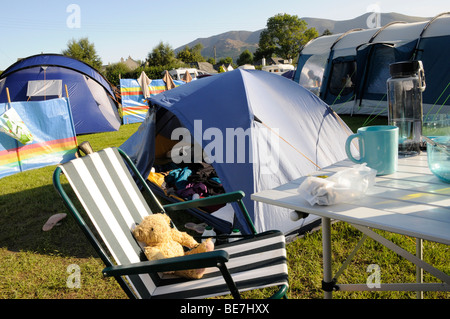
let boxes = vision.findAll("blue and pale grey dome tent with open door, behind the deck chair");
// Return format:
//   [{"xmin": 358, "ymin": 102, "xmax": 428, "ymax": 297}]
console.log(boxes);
[{"xmin": 121, "ymin": 69, "xmax": 351, "ymax": 238}]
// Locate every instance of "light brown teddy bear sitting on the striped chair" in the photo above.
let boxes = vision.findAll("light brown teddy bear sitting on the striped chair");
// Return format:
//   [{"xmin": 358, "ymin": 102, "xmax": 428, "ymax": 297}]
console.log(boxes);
[{"xmin": 133, "ymin": 213, "xmax": 214, "ymax": 279}]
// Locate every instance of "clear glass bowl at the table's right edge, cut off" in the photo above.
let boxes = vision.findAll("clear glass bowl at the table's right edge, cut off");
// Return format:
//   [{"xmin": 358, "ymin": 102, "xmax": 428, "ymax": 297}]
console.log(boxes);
[{"xmin": 427, "ymin": 136, "xmax": 450, "ymax": 183}]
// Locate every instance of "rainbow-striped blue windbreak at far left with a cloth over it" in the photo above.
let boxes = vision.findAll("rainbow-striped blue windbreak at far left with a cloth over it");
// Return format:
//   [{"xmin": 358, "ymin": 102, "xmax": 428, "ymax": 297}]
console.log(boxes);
[{"xmin": 0, "ymin": 98, "xmax": 78, "ymax": 178}]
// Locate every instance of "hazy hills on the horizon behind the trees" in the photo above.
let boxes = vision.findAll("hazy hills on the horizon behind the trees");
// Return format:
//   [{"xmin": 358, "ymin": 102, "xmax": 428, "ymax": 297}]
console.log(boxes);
[{"xmin": 175, "ymin": 12, "xmax": 430, "ymax": 61}]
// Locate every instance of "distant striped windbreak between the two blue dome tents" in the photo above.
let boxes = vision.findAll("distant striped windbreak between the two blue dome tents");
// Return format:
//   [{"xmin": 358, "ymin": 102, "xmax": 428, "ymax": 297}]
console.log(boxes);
[{"xmin": 120, "ymin": 79, "xmax": 185, "ymax": 124}]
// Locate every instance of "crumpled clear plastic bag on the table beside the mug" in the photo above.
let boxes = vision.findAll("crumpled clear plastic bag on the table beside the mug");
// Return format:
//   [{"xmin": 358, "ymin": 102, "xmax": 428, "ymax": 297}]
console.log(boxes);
[{"xmin": 297, "ymin": 164, "xmax": 377, "ymax": 205}]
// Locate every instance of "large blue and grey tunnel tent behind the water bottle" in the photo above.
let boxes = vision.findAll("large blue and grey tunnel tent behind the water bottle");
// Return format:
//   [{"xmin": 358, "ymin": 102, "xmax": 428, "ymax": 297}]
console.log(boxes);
[{"xmin": 294, "ymin": 13, "xmax": 450, "ymax": 122}]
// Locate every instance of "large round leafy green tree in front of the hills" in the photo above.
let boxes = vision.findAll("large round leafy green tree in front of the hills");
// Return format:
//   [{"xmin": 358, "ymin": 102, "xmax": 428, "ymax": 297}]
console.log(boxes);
[{"xmin": 255, "ymin": 13, "xmax": 319, "ymax": 59}]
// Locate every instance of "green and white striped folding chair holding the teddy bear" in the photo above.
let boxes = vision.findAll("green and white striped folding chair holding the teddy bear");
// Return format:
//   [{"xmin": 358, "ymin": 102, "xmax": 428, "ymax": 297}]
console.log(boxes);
[{"xmin": 53, "ymin": 148, "xmax": 288, "ymax": 299}]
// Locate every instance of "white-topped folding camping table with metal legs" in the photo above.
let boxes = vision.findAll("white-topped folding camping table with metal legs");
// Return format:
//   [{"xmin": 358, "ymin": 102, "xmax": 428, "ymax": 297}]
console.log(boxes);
[{"xmin": 251, "ymin": 153, "xmax": 450, "ymax": 298}]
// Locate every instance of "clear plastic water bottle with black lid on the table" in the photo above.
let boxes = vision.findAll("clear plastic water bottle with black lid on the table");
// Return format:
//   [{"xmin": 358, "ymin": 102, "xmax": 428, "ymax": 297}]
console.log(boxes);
[{"xmin": 387, "ymin": 61, "xmax": 425, "ymax": 156}]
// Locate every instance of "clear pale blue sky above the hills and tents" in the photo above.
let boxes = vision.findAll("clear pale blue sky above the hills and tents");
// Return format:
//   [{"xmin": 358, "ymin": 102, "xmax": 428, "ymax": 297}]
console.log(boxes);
[{"xmin": 0, "ymin": 0, "xmax": 450, "ymax": 70}]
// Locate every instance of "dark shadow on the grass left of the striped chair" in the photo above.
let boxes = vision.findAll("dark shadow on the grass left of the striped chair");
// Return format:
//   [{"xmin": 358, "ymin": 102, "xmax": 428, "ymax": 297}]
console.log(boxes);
[{"xmin": 0, "ymin": 184, "xmax": 97, "ymax": 258}]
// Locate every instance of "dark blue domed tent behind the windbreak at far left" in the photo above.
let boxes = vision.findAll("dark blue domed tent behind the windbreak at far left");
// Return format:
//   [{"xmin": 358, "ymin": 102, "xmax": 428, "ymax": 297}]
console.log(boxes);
[{"xmin": 0, "ymin": 54, "xmax": 121, "ymax": 134}]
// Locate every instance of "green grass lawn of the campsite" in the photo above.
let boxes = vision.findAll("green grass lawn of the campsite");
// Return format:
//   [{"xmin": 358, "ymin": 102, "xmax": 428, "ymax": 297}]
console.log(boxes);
[{"xmin": 0, "ymin": 116, "xmax": 450, "ymax": 299}]
